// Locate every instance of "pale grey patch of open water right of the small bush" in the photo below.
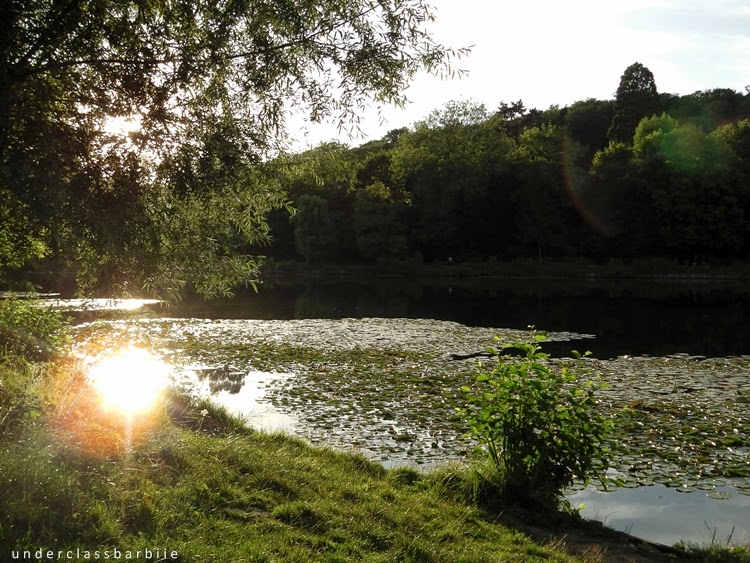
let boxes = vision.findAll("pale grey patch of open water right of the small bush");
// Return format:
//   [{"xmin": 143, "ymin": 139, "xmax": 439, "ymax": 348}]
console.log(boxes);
[{"xmin": 569, "ymin": 485, "xmax": 750, "ymax": 545}]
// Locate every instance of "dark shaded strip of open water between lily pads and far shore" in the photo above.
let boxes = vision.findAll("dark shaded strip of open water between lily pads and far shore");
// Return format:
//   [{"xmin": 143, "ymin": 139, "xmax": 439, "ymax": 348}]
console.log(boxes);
[{"xmin": 170, "ymin": 278, "xmax": 750, "ymax": 358}]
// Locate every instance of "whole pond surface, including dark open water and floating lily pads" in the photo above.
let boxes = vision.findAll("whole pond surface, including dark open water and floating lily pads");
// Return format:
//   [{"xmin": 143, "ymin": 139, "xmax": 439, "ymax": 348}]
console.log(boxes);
[{"xmin": 60, "ymin": 280, "xmax": 750, "ymax": 544}]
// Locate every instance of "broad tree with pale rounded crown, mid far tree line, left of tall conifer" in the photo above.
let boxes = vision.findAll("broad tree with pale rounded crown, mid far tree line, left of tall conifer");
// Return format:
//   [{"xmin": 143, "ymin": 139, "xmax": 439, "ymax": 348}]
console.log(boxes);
[{"xmin": 391, "ymin": 102, "xmax": 511, "ymax": 259}]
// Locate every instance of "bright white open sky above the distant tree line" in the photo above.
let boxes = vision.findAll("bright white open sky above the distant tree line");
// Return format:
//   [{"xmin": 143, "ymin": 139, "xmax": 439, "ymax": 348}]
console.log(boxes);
[{"xmin": 290, "ymin": 0, "xmax": 750, "ymax": 149}]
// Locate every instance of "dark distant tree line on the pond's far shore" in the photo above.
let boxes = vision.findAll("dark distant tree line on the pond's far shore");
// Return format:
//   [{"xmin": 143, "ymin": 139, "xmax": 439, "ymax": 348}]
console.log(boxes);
[{"xmin": 263, "ymin": 63, "xmax": 750, "ymax": 263}]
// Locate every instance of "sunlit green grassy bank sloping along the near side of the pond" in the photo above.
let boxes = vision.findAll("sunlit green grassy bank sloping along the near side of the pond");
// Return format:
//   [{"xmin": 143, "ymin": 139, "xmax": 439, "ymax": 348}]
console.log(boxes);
[{"xmin": 0, "ymin": 352, "xmax": 592, "ymax": 562}]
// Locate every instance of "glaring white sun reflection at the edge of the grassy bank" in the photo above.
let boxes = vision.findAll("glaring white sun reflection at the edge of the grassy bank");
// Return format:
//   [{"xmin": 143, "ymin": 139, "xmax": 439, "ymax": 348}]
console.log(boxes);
[{"xmin": 88, "ymin": 348, "xmax": 171, "ymax": 415}]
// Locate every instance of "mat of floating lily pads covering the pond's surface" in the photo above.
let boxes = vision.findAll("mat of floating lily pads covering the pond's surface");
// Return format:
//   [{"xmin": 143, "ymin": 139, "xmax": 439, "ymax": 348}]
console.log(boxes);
[{"xmin": 72, "ymin": 319, "xmax": 750, "ymax": 499}]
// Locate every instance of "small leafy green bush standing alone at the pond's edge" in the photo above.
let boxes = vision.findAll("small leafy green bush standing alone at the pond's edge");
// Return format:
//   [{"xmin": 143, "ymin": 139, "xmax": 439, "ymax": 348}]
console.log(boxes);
[{"xmin": 458, "ymin": 332, "xmax": 611, "ymax": 509}]
